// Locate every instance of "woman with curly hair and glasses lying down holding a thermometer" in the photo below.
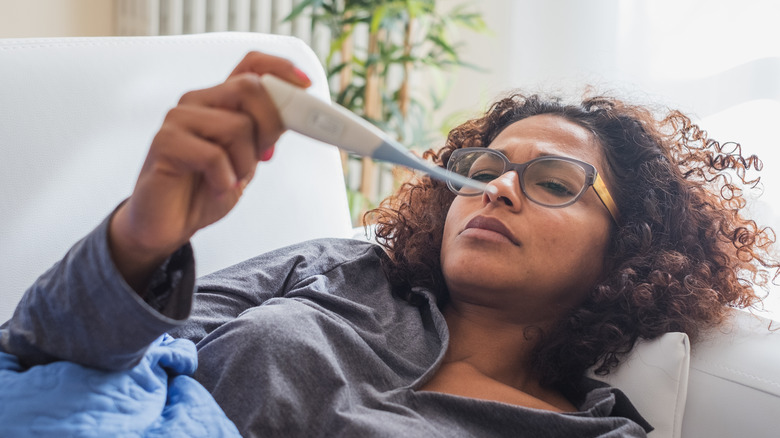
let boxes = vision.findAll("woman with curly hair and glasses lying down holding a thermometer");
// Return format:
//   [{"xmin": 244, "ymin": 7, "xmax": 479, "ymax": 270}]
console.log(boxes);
[{"xmin": 2, "ymin": 53, "xmax": 778, "ymax": 437}]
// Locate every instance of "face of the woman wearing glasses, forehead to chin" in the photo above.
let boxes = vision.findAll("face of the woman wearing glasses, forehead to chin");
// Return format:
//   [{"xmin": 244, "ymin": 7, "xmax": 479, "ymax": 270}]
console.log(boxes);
[{"xmin": 441, "ymin": 115, "xmax": 612, "ymax": 322}]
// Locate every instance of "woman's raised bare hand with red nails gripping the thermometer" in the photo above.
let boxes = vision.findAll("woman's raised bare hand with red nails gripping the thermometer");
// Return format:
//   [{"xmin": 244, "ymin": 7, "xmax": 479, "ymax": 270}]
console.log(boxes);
[{"xmin": 109, "ymin": 52, "xmax": 311, "ymax": 291}]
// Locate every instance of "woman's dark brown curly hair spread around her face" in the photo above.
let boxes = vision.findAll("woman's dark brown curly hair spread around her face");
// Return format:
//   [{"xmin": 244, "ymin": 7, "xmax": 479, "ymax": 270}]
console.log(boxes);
[{"xmin": 365, "ymin": 94, "xmax": 780, "ymax": 387}]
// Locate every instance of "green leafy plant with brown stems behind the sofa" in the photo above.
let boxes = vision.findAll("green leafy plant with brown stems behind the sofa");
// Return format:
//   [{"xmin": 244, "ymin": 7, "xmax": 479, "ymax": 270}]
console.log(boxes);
[{"xmin": 302, "ymin": 0, "xmax": 487, "ymax": 210}]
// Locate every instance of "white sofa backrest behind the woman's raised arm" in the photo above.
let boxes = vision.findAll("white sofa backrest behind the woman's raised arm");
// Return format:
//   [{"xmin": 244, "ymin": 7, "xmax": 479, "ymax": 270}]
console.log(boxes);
[{"xmin": 0, "ymin": 33, "xmax": 351, "ymax": 321}]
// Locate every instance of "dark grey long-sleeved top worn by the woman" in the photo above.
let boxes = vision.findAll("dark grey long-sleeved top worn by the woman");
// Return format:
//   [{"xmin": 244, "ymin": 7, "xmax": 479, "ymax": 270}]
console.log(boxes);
[{"xmin": 0, "ymin": 216, "xmax": 651, "ymax": 438}]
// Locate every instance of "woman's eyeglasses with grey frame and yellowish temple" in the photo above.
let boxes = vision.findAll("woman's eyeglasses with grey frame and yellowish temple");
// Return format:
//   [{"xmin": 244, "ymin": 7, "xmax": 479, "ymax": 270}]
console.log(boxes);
[{"xmin": 447, "ymin": 148, "xmax": 620, "ymax": 223}]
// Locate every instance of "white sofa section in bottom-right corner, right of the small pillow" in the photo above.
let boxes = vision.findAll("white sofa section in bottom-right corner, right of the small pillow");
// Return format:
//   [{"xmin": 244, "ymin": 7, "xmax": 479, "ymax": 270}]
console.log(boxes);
[{"xmin": 682, "ymin": 311, "xmax": 780, "ymax": 438}]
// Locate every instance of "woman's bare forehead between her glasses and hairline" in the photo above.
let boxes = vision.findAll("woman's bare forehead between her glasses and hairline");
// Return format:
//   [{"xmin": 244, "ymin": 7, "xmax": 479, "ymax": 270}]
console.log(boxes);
[{"xmin": 489, "ymin": 114, "xmax": 604, "ymax": 165}]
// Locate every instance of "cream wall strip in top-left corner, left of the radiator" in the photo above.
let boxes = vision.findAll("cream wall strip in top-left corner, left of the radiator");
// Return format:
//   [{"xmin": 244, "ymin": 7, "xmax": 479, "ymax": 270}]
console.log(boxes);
[{"xmin": 0, "ymin": 0, "xmax": 115, "ymax": 38}]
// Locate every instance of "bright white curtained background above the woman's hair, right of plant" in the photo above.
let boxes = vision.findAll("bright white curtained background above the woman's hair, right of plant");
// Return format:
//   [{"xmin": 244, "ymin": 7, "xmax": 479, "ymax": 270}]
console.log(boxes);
[{"xmin": 439, "ymin": 0, "xmax": 780, "ymax": 118}]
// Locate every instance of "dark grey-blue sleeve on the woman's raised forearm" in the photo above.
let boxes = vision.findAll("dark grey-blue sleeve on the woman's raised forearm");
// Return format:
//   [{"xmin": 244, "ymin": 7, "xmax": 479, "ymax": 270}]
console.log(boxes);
[{"xmin": 0, "ymin": 217, "xmax": 195, "ymax": 370}]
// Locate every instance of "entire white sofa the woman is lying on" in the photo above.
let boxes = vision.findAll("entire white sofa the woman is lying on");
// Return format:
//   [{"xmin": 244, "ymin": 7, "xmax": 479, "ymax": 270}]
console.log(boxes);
[{"xmin": 0, "ymin": 33, "xmax": 780, "ymax": 438}]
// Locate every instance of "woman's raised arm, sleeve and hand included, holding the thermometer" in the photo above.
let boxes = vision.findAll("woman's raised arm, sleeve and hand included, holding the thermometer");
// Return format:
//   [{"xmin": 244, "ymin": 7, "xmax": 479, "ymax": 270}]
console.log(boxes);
[{"xmin": 0, "ymin": 52, "xmax": 309, "ymax": 369}]
